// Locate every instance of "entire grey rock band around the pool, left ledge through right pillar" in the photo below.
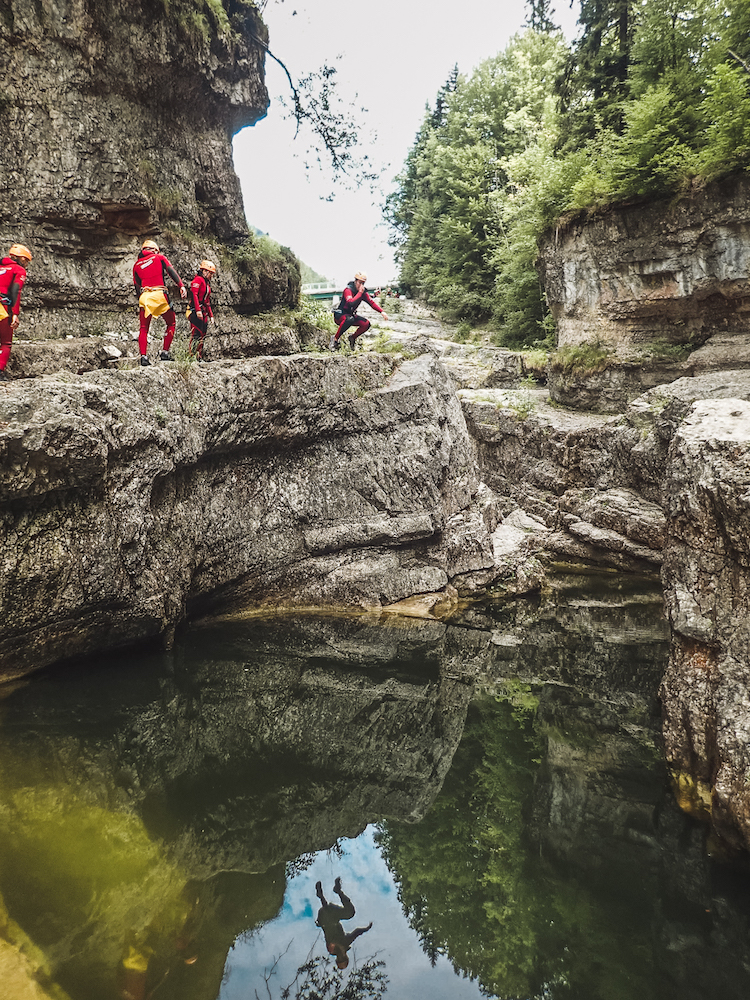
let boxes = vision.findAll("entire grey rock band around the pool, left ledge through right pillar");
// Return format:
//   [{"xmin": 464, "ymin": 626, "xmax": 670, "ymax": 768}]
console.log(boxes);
[{"xmin": 7, "ymin": 314, "xmax": 750, "ymax": 860}]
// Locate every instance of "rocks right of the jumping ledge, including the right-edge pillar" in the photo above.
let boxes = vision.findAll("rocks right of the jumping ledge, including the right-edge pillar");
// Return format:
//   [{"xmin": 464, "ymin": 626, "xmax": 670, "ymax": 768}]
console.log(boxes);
[{"xmin": 465, "ymin": 370, "xmax": 750, "ymax": 850}]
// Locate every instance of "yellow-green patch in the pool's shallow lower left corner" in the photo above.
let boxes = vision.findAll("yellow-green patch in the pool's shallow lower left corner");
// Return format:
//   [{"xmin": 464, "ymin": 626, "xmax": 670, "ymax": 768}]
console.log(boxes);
[{"xmin": 0, "ymin": 786, "xmax": 189, "ymax": 998}]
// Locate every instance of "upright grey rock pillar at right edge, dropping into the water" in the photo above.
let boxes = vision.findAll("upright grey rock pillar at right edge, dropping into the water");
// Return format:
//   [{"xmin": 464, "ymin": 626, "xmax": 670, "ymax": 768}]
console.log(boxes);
[{"xmin": 662, "ymin": 395, "xmax": 750, "ymax": 848}]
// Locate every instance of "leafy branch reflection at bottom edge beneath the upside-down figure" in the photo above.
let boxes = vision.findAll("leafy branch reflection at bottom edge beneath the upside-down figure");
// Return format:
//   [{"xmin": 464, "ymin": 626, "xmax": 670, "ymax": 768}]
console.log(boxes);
[{"xmin": 253, "ymin": 955, "xmax": 388, "ymax": 1000}]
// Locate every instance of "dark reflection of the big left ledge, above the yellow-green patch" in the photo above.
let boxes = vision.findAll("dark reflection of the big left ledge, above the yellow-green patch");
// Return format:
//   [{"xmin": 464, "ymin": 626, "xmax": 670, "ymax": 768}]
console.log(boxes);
[{"xmin": 0, "ymin": 618, "xmax": 482, "ymax": 877}]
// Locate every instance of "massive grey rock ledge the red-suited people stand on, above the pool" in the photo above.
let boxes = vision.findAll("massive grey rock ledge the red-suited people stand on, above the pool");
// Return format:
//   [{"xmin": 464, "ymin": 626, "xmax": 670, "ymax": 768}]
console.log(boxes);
[{"xmin": 0, "ymin": 354, "xmax": 506, "ymax": 676}]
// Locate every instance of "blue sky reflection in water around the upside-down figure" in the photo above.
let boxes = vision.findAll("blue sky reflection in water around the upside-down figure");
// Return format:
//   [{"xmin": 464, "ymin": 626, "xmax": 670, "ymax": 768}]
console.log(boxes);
[{"xmin": 219, "ymin": 827, "xmax": 481, "ymax": 1000}]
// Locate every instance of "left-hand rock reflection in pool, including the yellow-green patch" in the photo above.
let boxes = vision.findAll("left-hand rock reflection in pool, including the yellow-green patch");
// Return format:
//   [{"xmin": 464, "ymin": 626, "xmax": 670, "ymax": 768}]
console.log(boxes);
[{"xmin": 0, "ymin": 618, "xmax": 482, "ymax": 1000}]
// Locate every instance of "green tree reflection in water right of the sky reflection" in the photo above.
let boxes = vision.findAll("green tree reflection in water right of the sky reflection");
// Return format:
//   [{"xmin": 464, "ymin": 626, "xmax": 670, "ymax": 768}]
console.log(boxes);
[{"xmin": 378, "ymin": 692, "xmax": 653, "ymax": 1000}]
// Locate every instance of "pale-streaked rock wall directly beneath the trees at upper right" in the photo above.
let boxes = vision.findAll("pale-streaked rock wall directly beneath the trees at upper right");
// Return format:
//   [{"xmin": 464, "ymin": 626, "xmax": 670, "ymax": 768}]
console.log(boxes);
[{"xmin": 540, "ymin": 174, "xmax": 750, "ymax": 355}]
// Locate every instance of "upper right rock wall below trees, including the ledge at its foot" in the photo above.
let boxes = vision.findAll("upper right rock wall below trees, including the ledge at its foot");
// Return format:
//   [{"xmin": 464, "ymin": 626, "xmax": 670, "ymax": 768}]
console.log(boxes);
[{"xmin": 539, "ymin": 174, "xmax": 750, "ymax": 413}]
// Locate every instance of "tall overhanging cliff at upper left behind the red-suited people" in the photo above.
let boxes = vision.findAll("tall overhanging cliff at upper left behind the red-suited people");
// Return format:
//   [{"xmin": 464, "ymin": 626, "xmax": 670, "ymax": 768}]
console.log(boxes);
[{"xmin": 0, "ymin": 0, "xmax": 299, "ymax": 339}]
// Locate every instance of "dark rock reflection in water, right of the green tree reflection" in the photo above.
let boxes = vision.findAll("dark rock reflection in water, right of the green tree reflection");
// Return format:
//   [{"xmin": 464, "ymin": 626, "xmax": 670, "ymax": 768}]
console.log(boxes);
[{"xmin": 529, "ymin": 686, "xmax": 750, "ymax": 1000}]
